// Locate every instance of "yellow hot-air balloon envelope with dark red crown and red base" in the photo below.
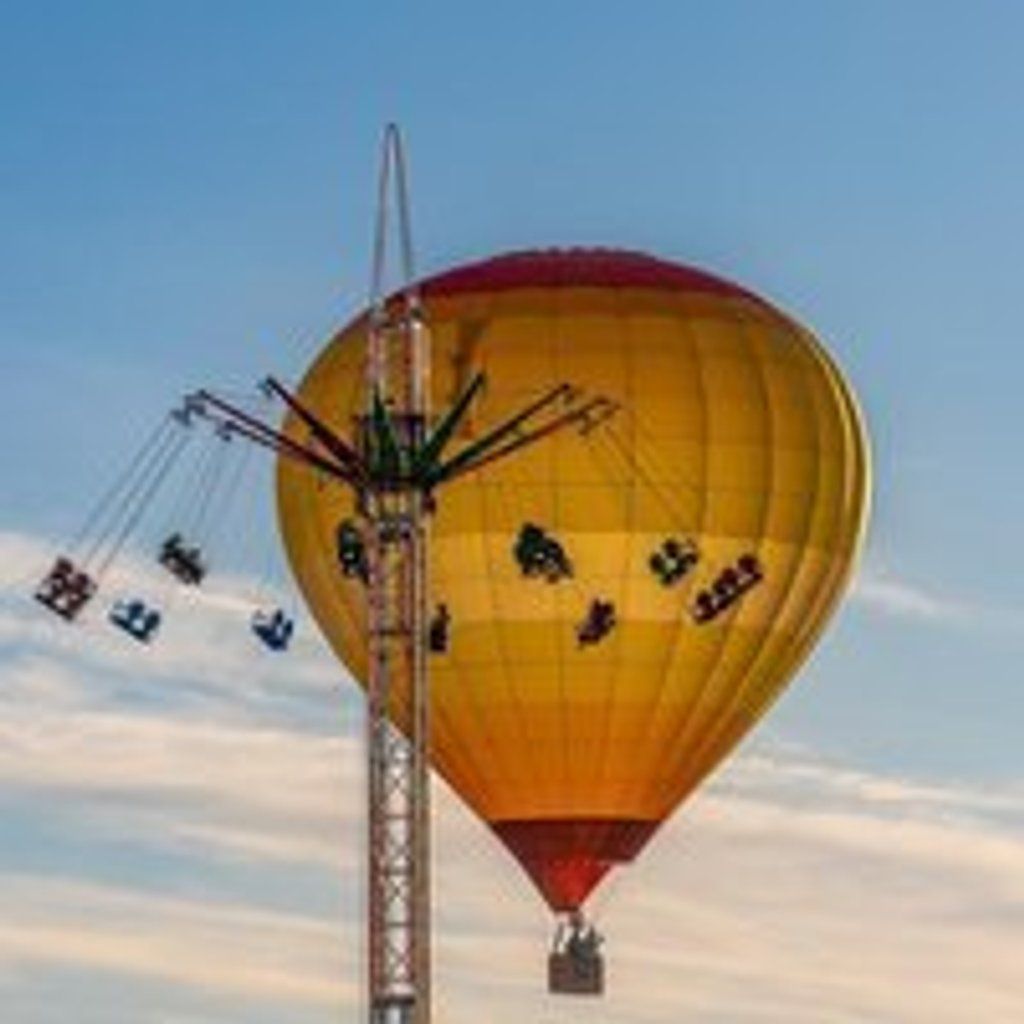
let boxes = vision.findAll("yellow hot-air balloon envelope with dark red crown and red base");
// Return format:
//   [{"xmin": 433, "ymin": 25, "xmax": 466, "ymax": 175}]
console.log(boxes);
[{"xmin": 279, "ymin": 250, "xmax": 868, "ymax": 908}]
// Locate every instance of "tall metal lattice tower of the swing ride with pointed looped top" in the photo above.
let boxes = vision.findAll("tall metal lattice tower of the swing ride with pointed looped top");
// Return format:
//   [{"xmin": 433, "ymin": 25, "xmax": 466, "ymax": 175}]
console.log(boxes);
[{"xmin": 361, "ymin": 125, "xmax": 430, "ymax": 1024}]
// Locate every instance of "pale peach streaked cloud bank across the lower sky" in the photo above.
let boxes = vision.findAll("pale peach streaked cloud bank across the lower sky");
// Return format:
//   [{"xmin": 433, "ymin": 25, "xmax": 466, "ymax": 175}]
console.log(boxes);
[{"xmin": 0, "ymin": 537, "xmax": 1024, "ymax": 1024}]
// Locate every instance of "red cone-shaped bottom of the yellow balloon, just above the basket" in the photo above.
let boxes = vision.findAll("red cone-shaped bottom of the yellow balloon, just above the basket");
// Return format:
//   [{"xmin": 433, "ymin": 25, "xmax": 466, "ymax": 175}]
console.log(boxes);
[{"xmin": 490, "ymin": 818, "xmax": 660, "ymax": 913}]
